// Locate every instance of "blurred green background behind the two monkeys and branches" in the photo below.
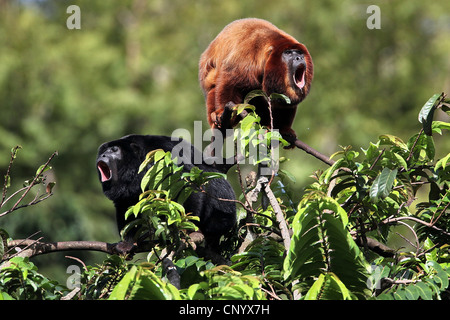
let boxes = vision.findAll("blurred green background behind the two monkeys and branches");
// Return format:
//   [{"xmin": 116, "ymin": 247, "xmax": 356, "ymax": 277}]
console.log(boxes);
[{"xmin": 0, "ymin": 0, "xmax": 450, "ymax": 280}]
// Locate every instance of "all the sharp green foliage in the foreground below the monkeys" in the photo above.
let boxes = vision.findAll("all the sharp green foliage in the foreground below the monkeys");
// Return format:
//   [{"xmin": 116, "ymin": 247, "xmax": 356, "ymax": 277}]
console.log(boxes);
[{"xmin": 0, "ymin": 93, "xmax": 450, "ymax": 300}]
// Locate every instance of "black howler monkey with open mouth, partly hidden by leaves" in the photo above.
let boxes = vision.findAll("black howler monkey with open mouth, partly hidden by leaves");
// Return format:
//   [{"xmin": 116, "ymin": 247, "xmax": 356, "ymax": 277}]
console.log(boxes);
[{"xmin": 97, "ymin": 135, "xmax": 236, "ymax": 247}]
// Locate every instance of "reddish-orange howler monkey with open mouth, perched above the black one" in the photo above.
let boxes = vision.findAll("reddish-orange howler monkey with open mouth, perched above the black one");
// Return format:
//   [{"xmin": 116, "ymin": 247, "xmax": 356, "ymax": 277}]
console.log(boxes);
[{"xmin": 199, "ymin": 18, "xmax": 313, "ymax": 146}]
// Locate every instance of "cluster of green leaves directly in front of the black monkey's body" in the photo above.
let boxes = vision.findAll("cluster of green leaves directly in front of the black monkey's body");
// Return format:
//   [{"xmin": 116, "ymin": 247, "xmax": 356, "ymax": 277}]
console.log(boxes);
[{"xmin": 124, "ymin": 149, "xmax": 223, "ymax": 246}]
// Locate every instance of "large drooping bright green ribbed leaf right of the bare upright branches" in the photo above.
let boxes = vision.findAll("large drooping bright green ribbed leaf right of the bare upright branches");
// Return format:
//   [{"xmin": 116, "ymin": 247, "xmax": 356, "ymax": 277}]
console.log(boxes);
[{"xmin": 283, "ymin": 197, "xmax": 367, "ymax": 295}]
